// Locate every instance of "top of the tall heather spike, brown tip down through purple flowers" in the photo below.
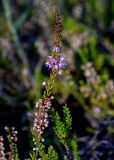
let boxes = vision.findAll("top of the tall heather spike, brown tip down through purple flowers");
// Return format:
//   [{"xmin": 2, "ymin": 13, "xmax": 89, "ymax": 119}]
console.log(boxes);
[{"xmin": 45, "ymin": 9, "xmax": 66, "ymax": 75}]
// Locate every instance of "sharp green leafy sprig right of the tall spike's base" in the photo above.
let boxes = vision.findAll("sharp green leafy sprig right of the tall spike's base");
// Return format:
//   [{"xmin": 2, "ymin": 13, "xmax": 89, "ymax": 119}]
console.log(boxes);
[{"xmin": 50, "ymin": 105, "xmax": 80, "ymax": 160}]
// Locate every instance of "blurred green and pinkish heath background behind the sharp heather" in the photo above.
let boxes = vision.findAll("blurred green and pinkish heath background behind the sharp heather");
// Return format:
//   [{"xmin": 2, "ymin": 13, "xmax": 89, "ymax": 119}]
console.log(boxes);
[{"xmin": 0, "ymin": 0, "xmax": 114, "ymax": 160}]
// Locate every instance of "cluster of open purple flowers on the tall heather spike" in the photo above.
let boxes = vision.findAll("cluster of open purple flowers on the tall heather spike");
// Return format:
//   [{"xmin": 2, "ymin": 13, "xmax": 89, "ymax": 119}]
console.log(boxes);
[{"xmin": 45, "ymin": 55, "xmax": 66, "ymax": 71}]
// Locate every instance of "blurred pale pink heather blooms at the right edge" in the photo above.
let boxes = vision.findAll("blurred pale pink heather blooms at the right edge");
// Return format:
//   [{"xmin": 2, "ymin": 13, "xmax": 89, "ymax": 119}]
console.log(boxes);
[{"xmin": 80, "ymin": 62, "xmax": 114, "ymax": 124}]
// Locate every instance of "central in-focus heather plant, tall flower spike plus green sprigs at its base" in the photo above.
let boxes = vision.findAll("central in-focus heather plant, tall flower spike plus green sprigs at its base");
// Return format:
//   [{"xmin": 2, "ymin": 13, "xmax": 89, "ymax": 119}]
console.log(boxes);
[{"xmin": 31, "ymin": 10, "xmax": 79, "ymax": 160}]
